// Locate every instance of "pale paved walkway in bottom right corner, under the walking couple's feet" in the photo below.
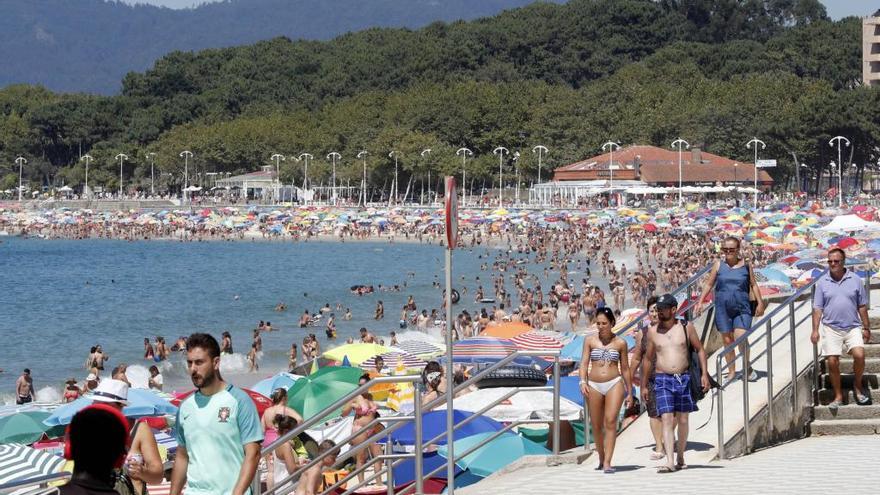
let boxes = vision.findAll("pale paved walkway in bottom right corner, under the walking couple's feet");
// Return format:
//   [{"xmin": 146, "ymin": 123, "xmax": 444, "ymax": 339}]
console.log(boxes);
[{"xmin": 456, "ymin": 435, "xmax": 880, "ymax": 495}]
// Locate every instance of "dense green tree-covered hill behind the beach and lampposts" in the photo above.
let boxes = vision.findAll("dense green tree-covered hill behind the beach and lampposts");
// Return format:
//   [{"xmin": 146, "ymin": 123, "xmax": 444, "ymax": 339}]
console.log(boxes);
[{"xmin": 0, "ymin": 0, "xmax": 880, "ymax": 198}]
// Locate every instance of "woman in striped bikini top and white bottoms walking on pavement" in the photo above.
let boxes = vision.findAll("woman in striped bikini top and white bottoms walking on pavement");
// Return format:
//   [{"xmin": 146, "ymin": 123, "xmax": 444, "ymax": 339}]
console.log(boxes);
[{"xmin": 579, "ymin": 307, "xmax": 632, "ymax": 473}]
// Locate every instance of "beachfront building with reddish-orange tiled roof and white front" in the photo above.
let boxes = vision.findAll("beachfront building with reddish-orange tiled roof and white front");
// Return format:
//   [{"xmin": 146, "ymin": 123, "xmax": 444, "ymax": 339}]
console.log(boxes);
[{"xmin": 529, "ymin": 145, "xmax": 773, "ymax": 205}]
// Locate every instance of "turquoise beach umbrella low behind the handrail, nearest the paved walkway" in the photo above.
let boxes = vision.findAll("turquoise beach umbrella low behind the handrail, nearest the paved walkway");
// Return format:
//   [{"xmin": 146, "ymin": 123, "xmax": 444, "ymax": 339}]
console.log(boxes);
[{"xmin": 437, "ymin": 433, "xmax": 550, "ymax": 477}]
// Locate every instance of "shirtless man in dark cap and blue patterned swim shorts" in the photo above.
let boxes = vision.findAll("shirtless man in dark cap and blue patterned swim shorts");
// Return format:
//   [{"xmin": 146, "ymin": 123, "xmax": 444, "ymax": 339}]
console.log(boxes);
[{"xmin": 641, "ymin": 294, "xmax": 709, "ymax": 473}]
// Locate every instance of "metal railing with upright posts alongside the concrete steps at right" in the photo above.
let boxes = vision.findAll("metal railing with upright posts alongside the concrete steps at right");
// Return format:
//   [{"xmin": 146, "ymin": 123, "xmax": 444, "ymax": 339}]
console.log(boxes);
[{"xmin": 715, "ymin": 269, "xmax": 827, "ymax": 459}]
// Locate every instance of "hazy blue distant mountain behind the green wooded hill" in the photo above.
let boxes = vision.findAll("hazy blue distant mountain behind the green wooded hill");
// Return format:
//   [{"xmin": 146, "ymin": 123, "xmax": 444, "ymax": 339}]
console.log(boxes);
[{"xmin": 0, "ymin": 0, "xmax": 560, "ymax": 95}]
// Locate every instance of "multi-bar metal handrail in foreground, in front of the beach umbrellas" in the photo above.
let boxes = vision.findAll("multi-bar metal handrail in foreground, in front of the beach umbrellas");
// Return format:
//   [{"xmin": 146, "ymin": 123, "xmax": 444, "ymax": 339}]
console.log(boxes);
[{"xmin": 252, "ymin": 349, "xmax": 560, "ymax": 495}]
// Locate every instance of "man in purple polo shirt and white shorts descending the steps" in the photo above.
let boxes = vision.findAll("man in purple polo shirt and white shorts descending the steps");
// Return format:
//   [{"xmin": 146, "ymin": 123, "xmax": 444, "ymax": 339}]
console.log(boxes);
[{"xmin": 810, "ymin": 248, "xmax": 871, "ymax": 409}]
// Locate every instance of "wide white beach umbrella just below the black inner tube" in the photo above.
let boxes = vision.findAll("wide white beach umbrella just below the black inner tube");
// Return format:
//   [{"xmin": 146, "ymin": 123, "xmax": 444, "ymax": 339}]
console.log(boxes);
[{"xmin": 450, "ymin": 388, "xmax": 583, "ymax": 423}]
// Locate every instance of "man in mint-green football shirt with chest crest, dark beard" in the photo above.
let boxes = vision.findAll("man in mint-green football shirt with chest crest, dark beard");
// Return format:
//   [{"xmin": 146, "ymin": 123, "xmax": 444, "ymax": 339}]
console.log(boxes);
[{"xmin": 171, "ymin": 333, "xmax": 263, "ymax": 495}]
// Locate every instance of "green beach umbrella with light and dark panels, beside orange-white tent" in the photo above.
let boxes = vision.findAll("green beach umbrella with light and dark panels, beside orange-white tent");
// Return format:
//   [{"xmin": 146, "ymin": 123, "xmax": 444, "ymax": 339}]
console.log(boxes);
[{"xmin": 287, "ymin": 366, "xmax": 363, "ymax": 419}]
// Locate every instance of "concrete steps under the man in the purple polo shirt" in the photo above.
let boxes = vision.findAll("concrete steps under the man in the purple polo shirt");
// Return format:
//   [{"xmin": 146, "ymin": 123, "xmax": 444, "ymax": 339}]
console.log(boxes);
[{"xmin": 810, "ymin": 330, "xmax": 880, "ymax": 435}]
